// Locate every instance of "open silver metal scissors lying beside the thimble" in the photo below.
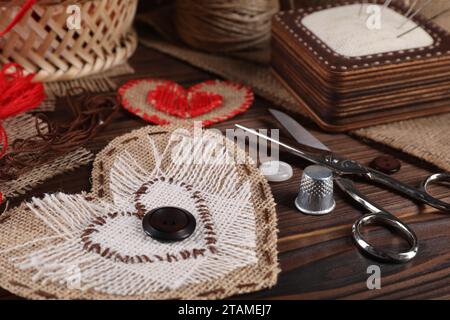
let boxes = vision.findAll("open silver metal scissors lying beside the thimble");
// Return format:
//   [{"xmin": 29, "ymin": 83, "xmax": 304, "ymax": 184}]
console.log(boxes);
[{"xmin": 236, "ymin": 109, "xmax": 450, "ymax": 263}]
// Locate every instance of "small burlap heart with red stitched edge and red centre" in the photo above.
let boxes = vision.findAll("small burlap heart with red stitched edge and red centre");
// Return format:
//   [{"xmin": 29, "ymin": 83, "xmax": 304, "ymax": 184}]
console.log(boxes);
[{"xmin": 119, "ymin": 79, "xmax": 254, "ymax": 126}]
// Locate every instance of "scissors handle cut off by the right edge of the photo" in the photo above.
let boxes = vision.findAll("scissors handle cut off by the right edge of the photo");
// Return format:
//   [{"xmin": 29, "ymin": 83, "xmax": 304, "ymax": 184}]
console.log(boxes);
[{"xmin": 367, "ymin": 169, "xmax": 450, "ymax": 212}]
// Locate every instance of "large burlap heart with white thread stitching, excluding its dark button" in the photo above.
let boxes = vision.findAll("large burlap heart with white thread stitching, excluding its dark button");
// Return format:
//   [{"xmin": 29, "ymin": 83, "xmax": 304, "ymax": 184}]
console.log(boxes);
[{"xmin": 0, "ymin": 126, "xmax": 279, "ymax": 299}]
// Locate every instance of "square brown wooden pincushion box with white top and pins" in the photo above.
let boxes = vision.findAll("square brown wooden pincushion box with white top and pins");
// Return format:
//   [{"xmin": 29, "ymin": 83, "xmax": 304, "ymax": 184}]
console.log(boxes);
[{"xmin": 272, "ymin": 0, "xmax": 450, "ymax": 131}]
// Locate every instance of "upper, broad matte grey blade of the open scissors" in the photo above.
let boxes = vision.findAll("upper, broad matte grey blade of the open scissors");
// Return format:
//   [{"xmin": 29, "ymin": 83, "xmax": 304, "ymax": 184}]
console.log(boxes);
[{"xmin": 269, "ymin": 109, "xmax": 330, "ymax": 151}]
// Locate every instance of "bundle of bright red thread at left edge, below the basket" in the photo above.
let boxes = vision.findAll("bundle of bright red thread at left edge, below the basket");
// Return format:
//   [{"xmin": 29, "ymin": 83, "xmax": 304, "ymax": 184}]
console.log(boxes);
[{"xmin": 0, "ymin": 63, "xmax": 45, "ymax": 158}]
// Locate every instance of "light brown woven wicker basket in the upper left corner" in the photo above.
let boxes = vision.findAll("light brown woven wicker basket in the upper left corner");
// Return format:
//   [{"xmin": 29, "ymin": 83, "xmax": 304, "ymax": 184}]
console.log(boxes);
[{"xmin": 0, "ymin": 0, "xmax": 138, "ymax": 81}]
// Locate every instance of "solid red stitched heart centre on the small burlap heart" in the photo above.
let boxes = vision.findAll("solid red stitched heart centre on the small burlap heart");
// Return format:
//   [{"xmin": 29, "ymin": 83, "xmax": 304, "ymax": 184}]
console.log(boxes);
[{"xmin": 147, "ymin": 81, "xmax": 223, "ymax": 119}]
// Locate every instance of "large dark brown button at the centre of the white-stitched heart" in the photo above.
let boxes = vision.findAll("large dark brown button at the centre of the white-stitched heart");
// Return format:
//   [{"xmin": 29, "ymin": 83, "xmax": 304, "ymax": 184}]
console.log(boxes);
[{"xmin": 142, "ymin": 207, "xmax": 197, "ymax": 241}]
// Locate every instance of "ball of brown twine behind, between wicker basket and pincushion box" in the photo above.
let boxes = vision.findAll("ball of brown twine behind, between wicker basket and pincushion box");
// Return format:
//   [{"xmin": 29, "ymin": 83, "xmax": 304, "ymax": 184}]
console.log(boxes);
[{"xmin": 175, "ymin": 0, "xmax": 279, "ymax": 53}]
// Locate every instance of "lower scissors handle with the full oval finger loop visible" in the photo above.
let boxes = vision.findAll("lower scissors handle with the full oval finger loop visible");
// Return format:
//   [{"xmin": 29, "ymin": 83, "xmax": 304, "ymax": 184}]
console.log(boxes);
[{"xmin": 336, "ymin": 178, "xmax": 419, "ymax": 263}]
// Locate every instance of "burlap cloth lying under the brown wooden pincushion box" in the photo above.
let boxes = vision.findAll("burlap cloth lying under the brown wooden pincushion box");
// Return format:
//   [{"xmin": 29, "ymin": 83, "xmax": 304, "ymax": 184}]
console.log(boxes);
[{"xmin": 138, "ymin": 0, "xmax": 450, "ymax": 171}]
